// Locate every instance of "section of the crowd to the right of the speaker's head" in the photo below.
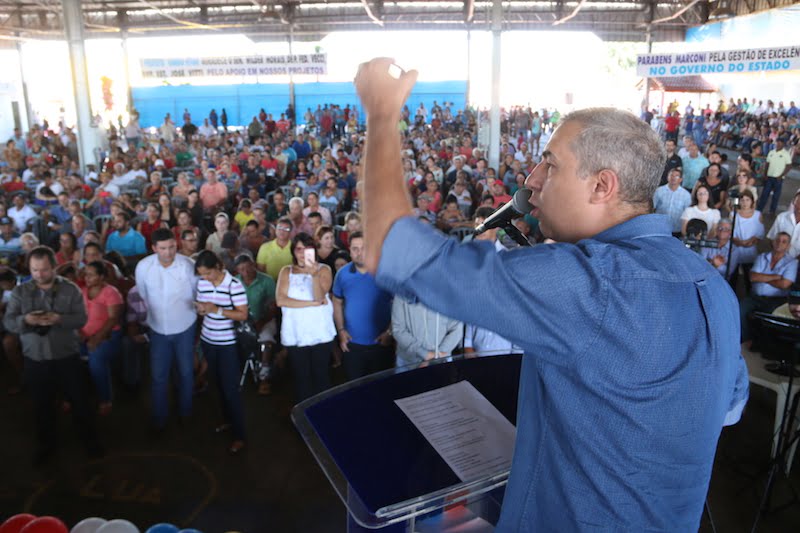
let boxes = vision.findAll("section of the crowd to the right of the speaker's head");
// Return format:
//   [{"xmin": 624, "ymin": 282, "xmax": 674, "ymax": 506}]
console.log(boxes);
[{"xmin": 642, "ymin": 98, "xmax": 800, "ymax": 350}]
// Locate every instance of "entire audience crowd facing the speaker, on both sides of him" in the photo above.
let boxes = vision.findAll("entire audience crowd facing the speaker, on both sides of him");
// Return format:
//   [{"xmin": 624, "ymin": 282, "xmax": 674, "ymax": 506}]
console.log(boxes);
[{"xmin": 0, "ymin": 92, "xmax": 800, "ymax": 466}]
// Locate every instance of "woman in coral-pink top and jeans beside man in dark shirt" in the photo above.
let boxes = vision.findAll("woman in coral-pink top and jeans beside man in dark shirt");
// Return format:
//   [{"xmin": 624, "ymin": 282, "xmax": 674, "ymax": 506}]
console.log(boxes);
[{"xmin": 80, "ymin": 261, "xmax": 123, "ymax": 415}]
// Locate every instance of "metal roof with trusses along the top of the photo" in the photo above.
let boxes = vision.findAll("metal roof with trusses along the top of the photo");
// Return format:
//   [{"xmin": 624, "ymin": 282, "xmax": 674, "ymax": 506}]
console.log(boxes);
[{"xmin": 0, "ymin": 0, "xmax": 796, "ymax": 41}]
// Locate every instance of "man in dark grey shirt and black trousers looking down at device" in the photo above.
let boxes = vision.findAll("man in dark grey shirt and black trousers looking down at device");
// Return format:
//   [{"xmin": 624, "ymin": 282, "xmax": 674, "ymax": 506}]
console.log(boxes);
[{"xmin": 3, "ymin": 246, "xmax": 102, "ymax": 465}]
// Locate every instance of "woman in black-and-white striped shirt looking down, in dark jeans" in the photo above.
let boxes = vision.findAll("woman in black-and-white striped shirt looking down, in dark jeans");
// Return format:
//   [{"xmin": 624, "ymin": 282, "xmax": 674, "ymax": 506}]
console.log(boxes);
[{"xmin": 195, "ymin": 250, "xmax": 248, "ymax": 454}]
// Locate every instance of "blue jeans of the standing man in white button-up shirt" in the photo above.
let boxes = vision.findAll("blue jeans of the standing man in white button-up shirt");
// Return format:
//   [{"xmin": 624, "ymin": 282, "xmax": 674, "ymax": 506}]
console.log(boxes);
[{"xmin": 150, "ymin": 324, "xmax": 195, "ymax": 428}]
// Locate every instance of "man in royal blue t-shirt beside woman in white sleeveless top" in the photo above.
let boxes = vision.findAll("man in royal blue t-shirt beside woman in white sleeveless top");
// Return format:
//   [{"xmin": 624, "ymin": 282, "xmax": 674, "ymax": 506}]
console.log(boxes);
[{"xmin": 333, "ymin": 231, "xmax": 394, "ymax": 380}]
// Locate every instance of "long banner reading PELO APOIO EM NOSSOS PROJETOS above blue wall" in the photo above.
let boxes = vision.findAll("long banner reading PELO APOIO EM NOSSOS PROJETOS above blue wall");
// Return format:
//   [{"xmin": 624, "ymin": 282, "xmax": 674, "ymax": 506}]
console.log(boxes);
[{"xmin": 141, "ymin": 54, "xmax": 328, "ymax": 79}]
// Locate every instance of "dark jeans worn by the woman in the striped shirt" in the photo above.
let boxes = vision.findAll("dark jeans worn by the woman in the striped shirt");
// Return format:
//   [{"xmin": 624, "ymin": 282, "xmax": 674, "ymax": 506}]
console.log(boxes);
[{"xmin": 201, "ymin": 341, "xmax": 244, "ymax": 440}]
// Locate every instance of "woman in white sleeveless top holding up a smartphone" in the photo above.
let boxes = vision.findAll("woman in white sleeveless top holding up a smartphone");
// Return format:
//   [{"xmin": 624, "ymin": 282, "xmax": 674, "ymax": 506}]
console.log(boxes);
[{"xmin": 276, "ymin": 232, "xmax": 336, "ymax": 402}]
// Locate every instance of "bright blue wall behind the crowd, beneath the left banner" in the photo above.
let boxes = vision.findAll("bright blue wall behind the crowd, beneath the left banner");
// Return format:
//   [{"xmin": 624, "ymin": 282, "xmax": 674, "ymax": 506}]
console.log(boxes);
[{"xmin": 133, "ymin": 81, "xmax": 467, "ymax": 127}]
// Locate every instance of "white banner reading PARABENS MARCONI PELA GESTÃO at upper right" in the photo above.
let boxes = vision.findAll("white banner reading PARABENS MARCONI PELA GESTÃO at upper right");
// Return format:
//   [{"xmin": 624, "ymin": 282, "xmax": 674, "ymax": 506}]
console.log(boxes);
[{"xmin": 636, "ymin": 46, "xmax": 800, "ymax": 77}]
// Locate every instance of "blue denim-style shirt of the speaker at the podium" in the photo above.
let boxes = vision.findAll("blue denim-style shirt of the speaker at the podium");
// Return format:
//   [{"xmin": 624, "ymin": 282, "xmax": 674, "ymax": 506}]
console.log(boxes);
[{"xmin": 377, "ymin": 215, "xmax": 748, "ymax": 532}]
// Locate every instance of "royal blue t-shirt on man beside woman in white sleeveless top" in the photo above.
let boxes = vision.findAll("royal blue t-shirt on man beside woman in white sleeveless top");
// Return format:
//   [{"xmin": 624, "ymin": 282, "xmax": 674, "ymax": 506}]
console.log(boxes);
[{"xmin": 333, "ymin": 263, "xmax": 392, "ymax": 346}]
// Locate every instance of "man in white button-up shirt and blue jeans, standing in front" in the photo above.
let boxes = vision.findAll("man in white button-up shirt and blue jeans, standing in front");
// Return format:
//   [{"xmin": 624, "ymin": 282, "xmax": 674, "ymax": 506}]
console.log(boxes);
[{"xmin": 136, "ymin": 228, "xmax": 197, "ymax": 431}]
